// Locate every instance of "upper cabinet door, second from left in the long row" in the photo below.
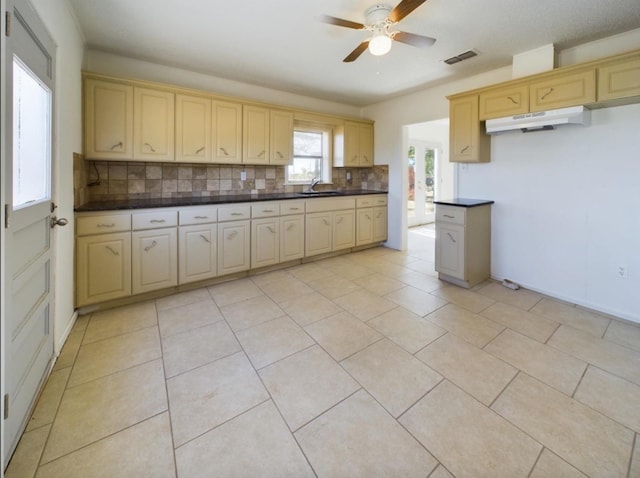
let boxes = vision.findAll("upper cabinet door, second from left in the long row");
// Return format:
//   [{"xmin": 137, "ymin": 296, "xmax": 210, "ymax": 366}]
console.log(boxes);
[{"xmin": 133, "ymin": 87, "xmax": 175, "ymax": 161}]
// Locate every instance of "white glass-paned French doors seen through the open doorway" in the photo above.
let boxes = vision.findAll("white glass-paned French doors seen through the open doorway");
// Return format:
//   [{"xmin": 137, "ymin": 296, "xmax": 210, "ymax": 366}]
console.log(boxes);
[{"xmin": 407, "ymin": 140, "xmax": 441, "ymax": 227}]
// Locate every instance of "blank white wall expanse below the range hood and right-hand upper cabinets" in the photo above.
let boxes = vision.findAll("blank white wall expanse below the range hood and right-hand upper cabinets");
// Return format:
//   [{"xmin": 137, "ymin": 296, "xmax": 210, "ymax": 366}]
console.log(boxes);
[{"xmin": 458, "ymin": 105, "xmax": 640, "ymax": 322}]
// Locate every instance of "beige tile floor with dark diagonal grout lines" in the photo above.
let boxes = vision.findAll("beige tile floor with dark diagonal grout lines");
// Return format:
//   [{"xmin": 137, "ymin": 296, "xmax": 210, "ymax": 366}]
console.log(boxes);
[{"xmin": 7, "ymin": 228, "xmax": 640, "ymax": 478}]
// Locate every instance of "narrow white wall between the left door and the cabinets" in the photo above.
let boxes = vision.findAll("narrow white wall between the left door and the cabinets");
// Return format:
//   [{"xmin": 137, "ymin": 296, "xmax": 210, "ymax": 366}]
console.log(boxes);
[{"xmin": 31, "ymin": 0, "xmax": 84, "ymax": 354}]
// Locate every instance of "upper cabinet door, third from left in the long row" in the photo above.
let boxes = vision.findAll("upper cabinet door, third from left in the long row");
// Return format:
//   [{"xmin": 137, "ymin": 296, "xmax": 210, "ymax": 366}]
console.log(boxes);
[{"xmin": 176, "ymin": 95, "xmax": 211, "ymax": 163}]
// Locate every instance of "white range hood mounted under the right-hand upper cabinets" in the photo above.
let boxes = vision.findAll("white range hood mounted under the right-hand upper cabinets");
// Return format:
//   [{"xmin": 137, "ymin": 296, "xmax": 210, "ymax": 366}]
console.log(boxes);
[{"xmin": 487, "ymin": 106, "xmax": 591, "ymax": 134}]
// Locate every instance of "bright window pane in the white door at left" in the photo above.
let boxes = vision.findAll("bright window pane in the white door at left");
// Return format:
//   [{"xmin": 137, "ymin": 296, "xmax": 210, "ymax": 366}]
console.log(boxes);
[{"xmin": 13, "ymin": 57, "xmax": 51, "ymax": 209}]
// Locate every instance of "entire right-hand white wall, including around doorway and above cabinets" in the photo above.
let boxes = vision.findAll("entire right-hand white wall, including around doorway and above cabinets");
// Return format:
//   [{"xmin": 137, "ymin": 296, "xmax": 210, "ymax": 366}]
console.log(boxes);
[{"xmin": 363, "ymin": 30, "xmax": 640, "ymax": 322}]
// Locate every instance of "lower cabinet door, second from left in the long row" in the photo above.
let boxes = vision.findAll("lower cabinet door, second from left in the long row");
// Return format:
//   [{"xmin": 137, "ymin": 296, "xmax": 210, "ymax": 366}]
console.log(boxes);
[{"xmin": 131, "ymin": 228, "xmax": 178, "ymax": 294}]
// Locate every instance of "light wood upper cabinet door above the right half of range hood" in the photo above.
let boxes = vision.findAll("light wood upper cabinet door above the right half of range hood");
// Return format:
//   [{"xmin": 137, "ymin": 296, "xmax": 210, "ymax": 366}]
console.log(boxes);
[{"xmin": 529, "ymin": 68, "xmax": 596, "ymax": 113}]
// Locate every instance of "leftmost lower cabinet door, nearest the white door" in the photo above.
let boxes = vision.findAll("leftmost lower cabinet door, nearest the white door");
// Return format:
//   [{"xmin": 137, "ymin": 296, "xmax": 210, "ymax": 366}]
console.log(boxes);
[{"xmin": 76, "ymin": 232, "xmax": 131, "ymax": 307}]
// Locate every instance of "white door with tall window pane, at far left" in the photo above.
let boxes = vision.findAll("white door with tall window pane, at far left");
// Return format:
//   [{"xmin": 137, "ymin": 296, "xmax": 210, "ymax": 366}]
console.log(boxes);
[{"xmin": 2, "ymin": 0, "xmax": 54, "ymax": 465}]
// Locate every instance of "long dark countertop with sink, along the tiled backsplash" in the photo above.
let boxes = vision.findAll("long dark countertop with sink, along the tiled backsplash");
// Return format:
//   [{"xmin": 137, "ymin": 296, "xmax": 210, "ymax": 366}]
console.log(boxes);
[{"xmin": 75, "ymin": 189, "xmax": 387, "ymax": 212}]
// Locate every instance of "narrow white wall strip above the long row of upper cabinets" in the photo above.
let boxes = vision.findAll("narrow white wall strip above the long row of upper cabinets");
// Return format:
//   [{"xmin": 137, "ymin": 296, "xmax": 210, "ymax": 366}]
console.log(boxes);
[{"xmin": 85, "ymin": 50, "xmax": 360, "ymax": 117}]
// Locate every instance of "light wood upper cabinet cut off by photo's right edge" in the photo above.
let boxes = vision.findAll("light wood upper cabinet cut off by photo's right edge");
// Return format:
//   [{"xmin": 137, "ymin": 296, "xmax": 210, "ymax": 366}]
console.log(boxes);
[{"xmin": 598, "ymin": 54, "xmax": 640, "ymax": 101}]
